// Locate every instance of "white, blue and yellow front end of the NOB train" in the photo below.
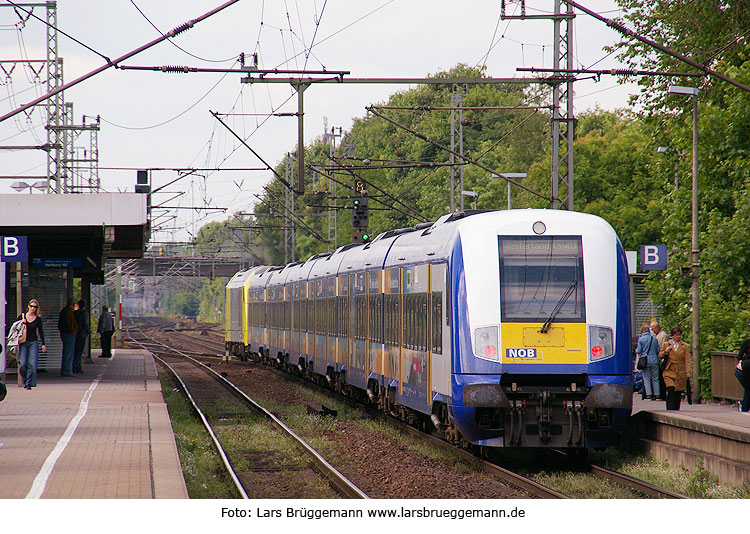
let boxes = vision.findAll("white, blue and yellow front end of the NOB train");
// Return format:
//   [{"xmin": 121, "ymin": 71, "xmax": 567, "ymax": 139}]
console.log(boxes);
[{"xmin": 452, "ymin": 226, "xmax": 632, "ymax": 448}]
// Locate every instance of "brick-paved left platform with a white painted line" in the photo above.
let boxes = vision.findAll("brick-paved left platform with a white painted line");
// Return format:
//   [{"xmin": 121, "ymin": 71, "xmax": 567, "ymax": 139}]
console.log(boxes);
[{"xmin": 0, "ymin": 349, "xmax": 188, "ymax": 499}]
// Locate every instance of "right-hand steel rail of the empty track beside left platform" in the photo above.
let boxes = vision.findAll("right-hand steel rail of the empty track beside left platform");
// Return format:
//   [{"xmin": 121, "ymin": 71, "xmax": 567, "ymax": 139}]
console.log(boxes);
[{"xmin": 128, "ymin": 328, "xmax": 369, "ymax": 499}]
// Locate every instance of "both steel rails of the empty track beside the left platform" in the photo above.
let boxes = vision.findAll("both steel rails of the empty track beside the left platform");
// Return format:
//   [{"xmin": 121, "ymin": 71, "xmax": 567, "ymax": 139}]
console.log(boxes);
[{"xmin": 128, "ymin": 329, "xmax": 368, "ymax": 499}]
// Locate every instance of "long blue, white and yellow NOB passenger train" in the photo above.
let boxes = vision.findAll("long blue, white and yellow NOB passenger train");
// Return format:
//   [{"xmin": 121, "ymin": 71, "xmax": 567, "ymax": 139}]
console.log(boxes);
[{"xmin": 225, "ymin": 209, "xmax": 632, "ymax": 449}]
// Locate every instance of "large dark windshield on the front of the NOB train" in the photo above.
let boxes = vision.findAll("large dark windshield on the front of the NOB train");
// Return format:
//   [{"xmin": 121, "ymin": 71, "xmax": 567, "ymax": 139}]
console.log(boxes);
[{"xmin": 498, "ymin": 236, "xmax": 586, "ymax": 323}]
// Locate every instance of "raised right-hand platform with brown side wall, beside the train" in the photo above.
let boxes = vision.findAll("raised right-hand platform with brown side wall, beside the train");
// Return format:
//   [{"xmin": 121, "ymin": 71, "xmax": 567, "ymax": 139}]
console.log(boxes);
[{"xmin": 632, "ymin": 393, "xmax": 750, "ymax": 486}]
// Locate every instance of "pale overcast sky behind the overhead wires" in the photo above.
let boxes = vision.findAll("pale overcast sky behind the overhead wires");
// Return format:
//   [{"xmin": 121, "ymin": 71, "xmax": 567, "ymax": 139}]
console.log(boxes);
[{"xmin": 0, "ymin": 0, "xmax": 644, "ymax": 241}]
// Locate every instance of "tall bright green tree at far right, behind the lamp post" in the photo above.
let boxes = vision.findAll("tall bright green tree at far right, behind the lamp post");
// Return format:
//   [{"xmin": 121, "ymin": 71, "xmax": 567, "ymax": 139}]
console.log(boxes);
[{"xmin": 618, "ymin": 0, "xmax": 750, "ymax": 396}]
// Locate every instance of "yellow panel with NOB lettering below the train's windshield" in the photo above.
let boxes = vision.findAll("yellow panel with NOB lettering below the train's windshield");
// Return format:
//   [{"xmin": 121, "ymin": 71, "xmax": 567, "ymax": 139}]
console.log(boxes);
[{"xmin": 500, "ymin": 323, "xmax": 588, "ymax": 364}]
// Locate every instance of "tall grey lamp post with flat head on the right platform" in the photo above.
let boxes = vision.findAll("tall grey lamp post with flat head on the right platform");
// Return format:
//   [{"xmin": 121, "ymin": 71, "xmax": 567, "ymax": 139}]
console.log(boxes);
[{"xmin": 668, "ymin": 85, "xmax": 700, "ymax": 402}]
